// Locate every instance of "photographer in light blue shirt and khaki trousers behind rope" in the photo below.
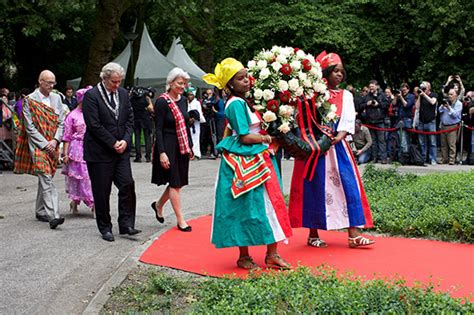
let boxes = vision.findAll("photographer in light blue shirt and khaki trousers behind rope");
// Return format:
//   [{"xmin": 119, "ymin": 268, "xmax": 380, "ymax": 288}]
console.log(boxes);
[{"xmin": 438, "ymin": 88, "xmax": 462, "ymax": 165}]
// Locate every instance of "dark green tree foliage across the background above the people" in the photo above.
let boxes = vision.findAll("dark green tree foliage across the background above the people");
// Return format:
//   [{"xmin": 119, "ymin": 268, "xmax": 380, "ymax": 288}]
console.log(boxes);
[{"xmin": 0, "ymin": 0, "xmax": 474, "ymax": 92}]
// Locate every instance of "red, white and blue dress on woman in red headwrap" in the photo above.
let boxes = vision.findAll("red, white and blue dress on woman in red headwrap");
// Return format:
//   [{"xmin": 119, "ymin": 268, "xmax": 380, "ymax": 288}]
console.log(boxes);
[{"xmin": 289, "ymin": 90, "xmax": 373, "ymax": 230}]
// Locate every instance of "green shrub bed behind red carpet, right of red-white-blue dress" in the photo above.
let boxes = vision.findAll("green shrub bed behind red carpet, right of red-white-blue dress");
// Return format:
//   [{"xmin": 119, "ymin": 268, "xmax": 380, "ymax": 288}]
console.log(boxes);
[{"xmin": 363, "ymin": 164, "xmax": 474, "ymax": 243}]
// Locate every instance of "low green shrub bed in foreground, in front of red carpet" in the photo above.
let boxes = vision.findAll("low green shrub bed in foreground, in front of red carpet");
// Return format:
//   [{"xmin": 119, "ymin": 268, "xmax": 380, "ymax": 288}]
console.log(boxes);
[{"xmin": 192, "ymin": 267, "xmax": 474, "ymax": 314}]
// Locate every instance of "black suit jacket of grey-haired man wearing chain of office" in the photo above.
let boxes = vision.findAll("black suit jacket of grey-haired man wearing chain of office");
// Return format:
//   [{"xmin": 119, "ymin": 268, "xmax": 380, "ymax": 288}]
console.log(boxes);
[{"xmin": 82, "ymin": 86, "xmax": 133, "ymax": 162}]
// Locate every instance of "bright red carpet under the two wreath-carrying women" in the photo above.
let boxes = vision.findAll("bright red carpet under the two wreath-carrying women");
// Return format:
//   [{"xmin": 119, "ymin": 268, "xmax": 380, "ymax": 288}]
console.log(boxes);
[{"xmin": 140, "ymin": 216, "xmax": 474, "ymax": 297}]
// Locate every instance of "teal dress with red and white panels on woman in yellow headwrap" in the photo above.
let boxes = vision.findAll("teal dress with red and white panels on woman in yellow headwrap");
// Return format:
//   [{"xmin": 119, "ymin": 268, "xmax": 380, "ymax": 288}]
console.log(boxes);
[{"xmin": 211, "ymin": 97, "xmax": 292, "ymax": 248}]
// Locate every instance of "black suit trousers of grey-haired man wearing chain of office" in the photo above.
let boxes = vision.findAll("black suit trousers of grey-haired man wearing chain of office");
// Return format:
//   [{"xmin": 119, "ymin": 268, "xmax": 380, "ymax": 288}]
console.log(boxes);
[{"xmin": 87, "ymin": 158, "xmax": 137, "ymax": 234}]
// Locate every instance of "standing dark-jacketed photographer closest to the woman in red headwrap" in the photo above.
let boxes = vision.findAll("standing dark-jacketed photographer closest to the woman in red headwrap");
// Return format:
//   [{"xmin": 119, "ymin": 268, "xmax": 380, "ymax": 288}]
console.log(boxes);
[{"xmin": 360, "ymin": 80, "xmax": 390, "ymax": 164}]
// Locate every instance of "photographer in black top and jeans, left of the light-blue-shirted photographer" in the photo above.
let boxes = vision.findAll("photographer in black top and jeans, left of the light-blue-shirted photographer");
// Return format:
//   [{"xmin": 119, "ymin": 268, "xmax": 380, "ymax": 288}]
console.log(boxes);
[{"xmin": 415, "ymin": 81, "xmax": 438, "ymax": 165}]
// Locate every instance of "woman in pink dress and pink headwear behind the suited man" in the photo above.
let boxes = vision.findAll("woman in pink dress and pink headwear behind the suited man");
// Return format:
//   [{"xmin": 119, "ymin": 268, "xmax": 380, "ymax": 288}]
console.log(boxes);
[{"xmin": 62, "ymin": 86, "xmax": 95, "ymax": 217}]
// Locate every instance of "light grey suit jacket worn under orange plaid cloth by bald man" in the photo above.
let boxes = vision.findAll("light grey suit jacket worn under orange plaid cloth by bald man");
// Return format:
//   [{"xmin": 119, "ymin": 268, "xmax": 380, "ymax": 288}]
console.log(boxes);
[{"xmin": 23, "ymin": 89, "xmax": 64, "ymax": 152}]
